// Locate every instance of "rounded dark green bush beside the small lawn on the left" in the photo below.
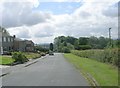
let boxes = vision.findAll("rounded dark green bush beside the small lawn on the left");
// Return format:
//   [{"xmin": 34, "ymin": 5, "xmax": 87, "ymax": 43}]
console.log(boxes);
[{"xmin": 12, "ymin": 52, "xmax": 28, "ymax": 63}]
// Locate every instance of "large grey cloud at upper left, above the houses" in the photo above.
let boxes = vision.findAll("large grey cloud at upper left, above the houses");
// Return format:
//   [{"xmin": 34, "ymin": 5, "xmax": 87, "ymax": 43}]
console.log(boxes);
[{"xmin": 2, "ymin": 2, "xmax": 51, "ymax": 27}]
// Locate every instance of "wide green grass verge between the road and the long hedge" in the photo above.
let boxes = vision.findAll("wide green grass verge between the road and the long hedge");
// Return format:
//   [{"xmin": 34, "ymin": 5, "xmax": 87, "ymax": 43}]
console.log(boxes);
[{"xmin": 64, "ymin": 54, "xmax": 118, "ymax": 86}]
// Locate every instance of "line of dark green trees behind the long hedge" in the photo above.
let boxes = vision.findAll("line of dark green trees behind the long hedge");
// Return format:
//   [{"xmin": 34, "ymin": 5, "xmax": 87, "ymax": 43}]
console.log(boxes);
[{"xmin": 54, "ymin": 36, "xmax": 120, "ymax": 52}]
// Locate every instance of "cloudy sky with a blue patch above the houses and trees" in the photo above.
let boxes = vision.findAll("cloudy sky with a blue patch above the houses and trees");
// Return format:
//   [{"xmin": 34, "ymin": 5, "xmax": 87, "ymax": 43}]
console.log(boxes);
[{"xmin": 0, "ymin": 0, "xmax": 119, "ymax": 43}]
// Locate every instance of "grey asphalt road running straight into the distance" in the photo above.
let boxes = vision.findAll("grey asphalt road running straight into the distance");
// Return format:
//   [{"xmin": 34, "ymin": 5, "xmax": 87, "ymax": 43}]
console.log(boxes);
[{"xmin": 2, "ymin": 54, "xmax": 89, "ymax": 86}]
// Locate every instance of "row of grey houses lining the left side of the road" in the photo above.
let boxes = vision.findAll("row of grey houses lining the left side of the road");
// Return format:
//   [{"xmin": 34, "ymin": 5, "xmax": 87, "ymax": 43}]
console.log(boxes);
[{"xmin": 0, "ymin": 27, "xmax": 34, "ymax": 54}]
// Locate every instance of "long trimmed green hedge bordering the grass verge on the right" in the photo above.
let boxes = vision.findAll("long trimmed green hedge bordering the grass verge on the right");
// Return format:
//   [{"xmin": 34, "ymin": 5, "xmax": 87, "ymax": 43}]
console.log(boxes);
[{"xmin": 71, "ymin": 48, "xmax": 120, "ymax": 66}]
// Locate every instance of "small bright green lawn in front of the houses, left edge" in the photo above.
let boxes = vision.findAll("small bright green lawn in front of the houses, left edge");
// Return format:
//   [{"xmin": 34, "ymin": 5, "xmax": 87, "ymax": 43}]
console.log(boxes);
[{"xmin": 0, "ymin": 56, "xmax": 14, "ymax": 65}]
